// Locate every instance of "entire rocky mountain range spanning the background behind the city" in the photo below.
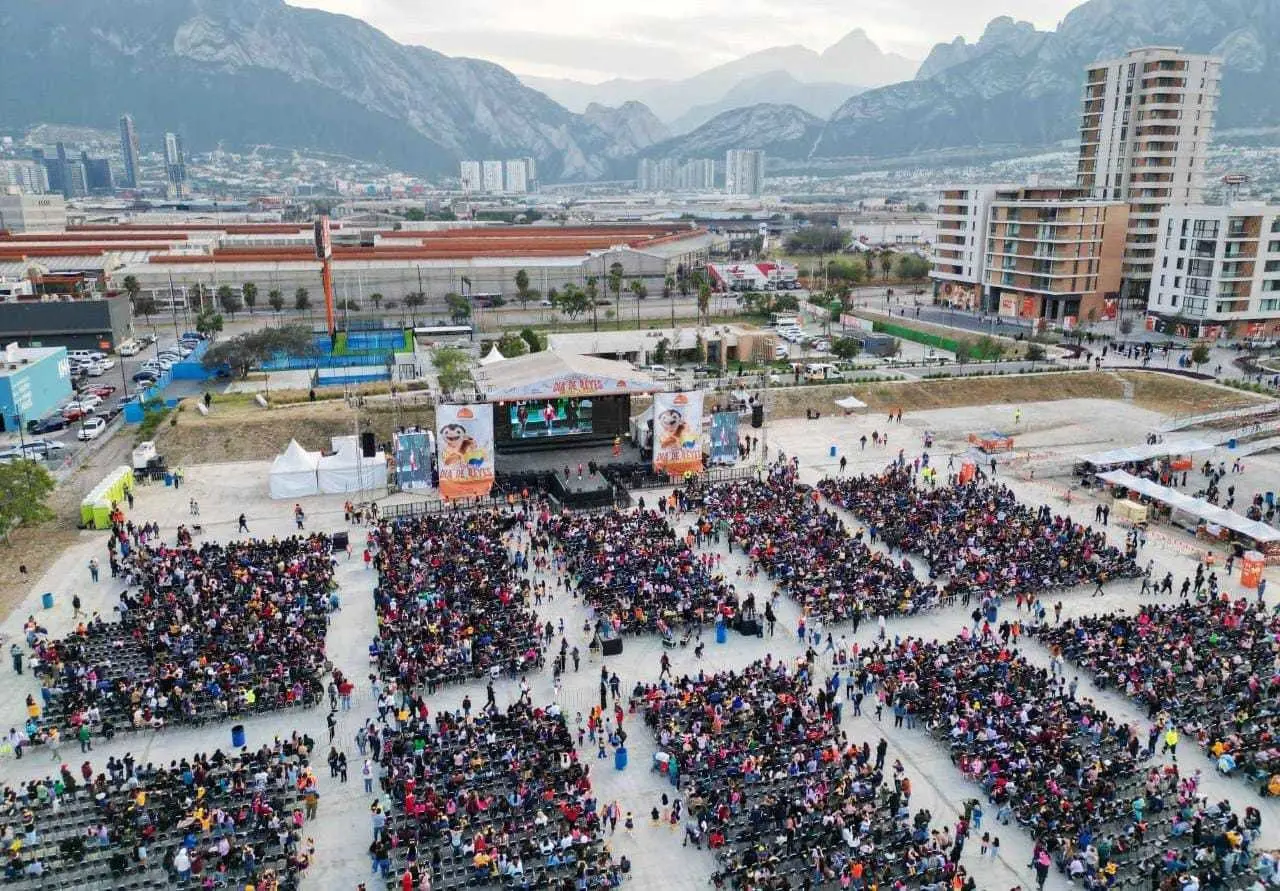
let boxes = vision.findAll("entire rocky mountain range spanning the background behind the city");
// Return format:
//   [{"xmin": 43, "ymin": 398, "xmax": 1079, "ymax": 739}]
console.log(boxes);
[{"xmin": 0, "ymin": 0, "xmax": 1280, "ymax": 182}]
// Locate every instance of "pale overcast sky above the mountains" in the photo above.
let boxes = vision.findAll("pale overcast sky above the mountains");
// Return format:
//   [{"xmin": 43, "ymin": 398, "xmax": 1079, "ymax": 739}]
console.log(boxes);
[{"xmin": 288, "ymin": 0, "xmax": 1082, "ymax": 82}]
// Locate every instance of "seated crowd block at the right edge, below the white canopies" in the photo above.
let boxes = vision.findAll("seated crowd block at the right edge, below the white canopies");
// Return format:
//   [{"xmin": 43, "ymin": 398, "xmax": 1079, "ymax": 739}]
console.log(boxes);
[{"xmin": 1036, "ymin": 598, "xmax": 1280, "ymax": 795}]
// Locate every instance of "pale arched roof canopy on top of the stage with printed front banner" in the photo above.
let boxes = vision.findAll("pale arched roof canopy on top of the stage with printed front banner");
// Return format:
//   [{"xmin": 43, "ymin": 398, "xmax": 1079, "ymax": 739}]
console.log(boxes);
[{"xmin": 476, "ymin": 351, "xmax": 664, "ymax": 402}]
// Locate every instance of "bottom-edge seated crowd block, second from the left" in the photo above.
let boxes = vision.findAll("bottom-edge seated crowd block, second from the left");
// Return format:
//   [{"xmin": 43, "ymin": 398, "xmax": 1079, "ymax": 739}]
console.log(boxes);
[{"xmin": 370, "ymin": 694, "xmax": 630, "ymax": 891}]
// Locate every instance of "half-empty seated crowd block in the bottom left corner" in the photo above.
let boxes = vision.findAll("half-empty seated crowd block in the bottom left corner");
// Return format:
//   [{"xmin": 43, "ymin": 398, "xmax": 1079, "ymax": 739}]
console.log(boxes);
[{"xmin": 0, "ymin": 735, "xmax": 315, "ymax": 891}]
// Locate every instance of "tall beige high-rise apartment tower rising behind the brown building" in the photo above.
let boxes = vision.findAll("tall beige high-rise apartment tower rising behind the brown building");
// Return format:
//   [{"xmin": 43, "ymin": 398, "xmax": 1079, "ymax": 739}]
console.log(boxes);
[{"xmin": 1076, "ymin": 46, "xmax": 1222, "ymax": 309}]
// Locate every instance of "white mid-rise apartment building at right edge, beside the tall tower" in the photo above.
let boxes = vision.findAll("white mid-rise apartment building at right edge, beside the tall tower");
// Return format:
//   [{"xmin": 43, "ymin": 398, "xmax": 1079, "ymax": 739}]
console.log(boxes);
[{"xmin": 1147, "ymin": 204, "xmax": 1280, "ymax": 338}]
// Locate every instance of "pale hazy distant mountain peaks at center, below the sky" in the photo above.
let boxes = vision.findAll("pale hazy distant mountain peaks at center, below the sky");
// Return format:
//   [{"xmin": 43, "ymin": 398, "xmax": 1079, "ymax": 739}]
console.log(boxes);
[{"xmin": 522, "ymin": 28, "xmax": 918, "ymax": 126}]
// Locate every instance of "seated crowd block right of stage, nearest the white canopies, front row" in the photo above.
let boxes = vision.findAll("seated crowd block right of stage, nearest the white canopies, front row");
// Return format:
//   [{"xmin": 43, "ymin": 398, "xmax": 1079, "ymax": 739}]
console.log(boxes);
[{"xmin": 818, "ymin": 461, "xmax": 1140, "ymax": 600}]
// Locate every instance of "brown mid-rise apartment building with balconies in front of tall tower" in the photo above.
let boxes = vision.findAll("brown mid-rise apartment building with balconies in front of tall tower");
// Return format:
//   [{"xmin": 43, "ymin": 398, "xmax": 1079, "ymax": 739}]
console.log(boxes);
[{"xmin": 983, "ymin": 187, "xmax": 1129, "ymax": 328}]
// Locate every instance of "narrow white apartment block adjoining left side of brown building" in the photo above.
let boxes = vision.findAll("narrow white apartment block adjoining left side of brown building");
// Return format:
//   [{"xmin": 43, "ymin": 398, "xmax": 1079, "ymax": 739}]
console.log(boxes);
[{"xmin": 929, "ymin": 183, "xmax": 1018, "ymax": 310}]
